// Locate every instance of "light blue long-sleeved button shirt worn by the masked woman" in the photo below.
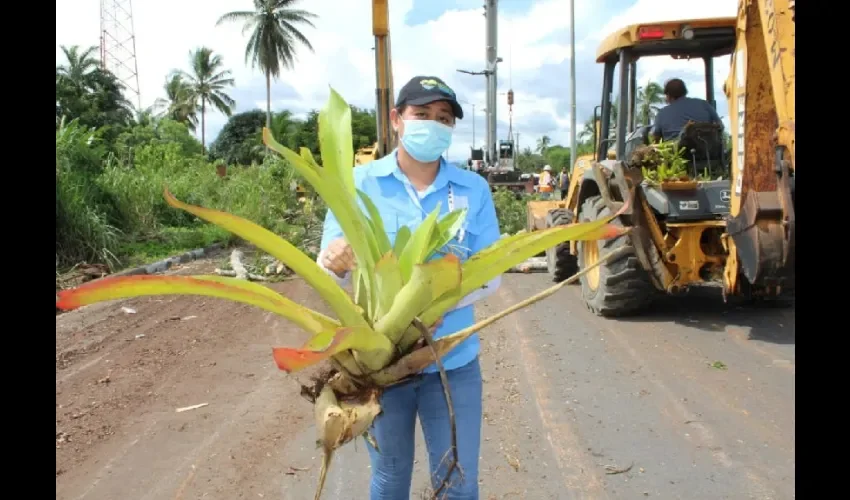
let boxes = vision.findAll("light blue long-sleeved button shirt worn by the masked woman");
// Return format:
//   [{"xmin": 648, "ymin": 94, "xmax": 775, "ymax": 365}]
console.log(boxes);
[{"xmin": 321, "ymin": 151, "xmax": 500, "ymax": 372}]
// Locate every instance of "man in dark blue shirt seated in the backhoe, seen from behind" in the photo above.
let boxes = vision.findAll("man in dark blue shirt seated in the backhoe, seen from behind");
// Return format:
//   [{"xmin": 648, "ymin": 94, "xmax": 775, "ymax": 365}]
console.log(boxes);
[{"xmin": 650, "ymin": 78, "xmax": 723, "ymax": 142}]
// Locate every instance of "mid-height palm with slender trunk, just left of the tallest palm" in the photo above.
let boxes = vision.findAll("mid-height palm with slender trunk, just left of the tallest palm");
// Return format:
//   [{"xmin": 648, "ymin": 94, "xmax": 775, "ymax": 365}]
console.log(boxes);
[{"xmin": 178, "ymin": 47, "xmax": 236, "ymax": 151}]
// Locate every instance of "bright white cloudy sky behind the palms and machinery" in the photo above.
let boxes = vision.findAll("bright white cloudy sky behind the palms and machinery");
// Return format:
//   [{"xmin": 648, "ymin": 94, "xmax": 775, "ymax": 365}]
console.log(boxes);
[{"xmin": 56, "ymin": 0, "xmax": 735, "ymax": 159}]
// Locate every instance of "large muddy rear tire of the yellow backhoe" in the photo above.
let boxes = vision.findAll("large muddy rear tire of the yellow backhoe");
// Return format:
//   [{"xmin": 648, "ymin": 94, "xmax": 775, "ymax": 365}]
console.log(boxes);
[{"xmin": 578, "ymin": 196, "xmax": 658, "ymax": 317}]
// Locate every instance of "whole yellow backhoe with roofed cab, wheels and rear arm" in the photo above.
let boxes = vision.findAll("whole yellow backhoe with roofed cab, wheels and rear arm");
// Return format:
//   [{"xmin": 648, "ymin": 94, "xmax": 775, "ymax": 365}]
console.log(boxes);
[{"xmin": 540, "ymin": 7, "xmax": 794, "ymax": 316}]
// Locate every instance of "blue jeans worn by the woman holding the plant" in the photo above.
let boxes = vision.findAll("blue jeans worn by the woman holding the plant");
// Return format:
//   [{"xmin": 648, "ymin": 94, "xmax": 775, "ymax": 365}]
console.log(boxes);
[{"xmin": 368, "ymin": 358, "xmax": 482, "ymax": 500}]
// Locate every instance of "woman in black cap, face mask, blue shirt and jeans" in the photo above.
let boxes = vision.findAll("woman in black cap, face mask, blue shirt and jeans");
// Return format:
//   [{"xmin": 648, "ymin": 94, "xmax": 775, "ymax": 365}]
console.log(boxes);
[{"xmin": 318, "ymin": 76, "xmax": 500, "ymax": 500}]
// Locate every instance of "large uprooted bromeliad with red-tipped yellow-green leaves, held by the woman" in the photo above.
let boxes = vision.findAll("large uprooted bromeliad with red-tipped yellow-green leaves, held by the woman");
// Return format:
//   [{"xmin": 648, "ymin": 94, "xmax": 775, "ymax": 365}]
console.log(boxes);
[{"xmin": 57, "ymin": 89, "xmax": 623, "ymax": 498}]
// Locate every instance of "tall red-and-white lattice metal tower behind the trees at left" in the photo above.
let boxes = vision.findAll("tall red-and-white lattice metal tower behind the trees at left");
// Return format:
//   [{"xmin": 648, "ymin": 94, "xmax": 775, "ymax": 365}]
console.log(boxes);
[{"xmin": 100, "ymin": 0, "xmax": 142, "ymax": 109}]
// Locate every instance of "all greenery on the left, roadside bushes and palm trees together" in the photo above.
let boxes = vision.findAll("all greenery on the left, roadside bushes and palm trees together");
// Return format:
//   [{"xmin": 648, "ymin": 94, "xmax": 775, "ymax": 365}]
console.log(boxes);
[{"xmin": 56, "ymin": 0, "xmax": 344, "ymax": 274}]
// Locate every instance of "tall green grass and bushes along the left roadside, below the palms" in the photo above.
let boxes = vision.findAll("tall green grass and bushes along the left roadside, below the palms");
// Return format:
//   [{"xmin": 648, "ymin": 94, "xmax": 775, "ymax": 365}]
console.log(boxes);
[{"xmin": 56, "ymin": 120, "xmax": 325, "ymax": 272}]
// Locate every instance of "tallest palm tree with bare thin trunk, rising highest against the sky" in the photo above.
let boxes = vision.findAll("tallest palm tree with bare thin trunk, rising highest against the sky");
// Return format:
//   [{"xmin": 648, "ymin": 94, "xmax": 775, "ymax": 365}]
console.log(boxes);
[{"xmin": 216, "ymin": 0, "xmax": 318, "ymax": 127}]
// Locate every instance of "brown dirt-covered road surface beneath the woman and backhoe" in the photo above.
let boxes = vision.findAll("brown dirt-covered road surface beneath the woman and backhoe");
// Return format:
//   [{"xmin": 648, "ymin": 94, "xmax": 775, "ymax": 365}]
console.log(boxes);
[{"xmin": 56, "ymin": 261, "xmax": 795, "ymax": 500}]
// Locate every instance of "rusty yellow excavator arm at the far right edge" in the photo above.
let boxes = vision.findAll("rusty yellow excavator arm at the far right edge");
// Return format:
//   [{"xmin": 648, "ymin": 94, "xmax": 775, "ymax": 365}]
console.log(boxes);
[{"xmin": 724, "ymin": 0, "xmax": 796, "ymax": 296}]
